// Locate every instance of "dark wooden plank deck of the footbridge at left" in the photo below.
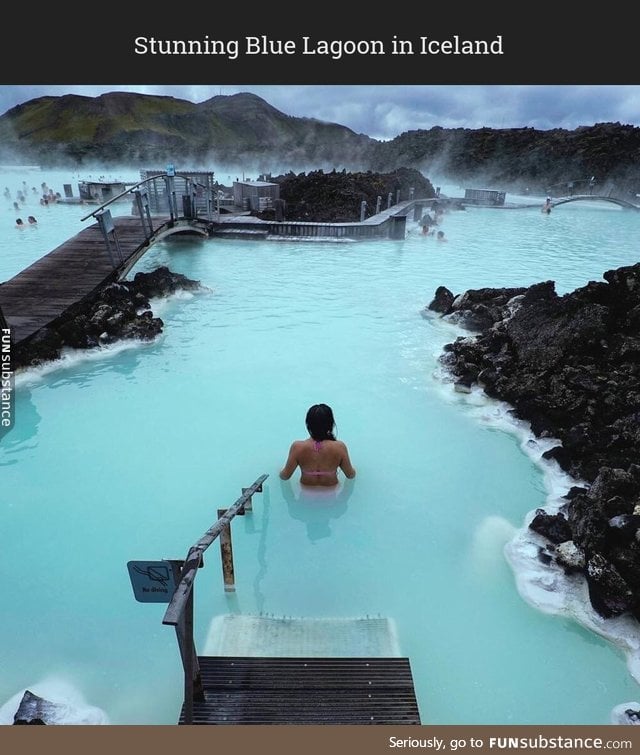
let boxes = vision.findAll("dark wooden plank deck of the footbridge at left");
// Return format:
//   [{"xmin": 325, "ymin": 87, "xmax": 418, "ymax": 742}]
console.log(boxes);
[{"xmin": 0, "ymin": 216, "xmax": 168, "ymax": 345}]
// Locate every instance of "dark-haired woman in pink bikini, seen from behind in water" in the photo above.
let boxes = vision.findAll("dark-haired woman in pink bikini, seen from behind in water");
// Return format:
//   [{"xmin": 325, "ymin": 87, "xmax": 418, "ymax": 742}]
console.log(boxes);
[{"xmin": 280, "ymin": 404, "xmax": 356, "ymax": 487}]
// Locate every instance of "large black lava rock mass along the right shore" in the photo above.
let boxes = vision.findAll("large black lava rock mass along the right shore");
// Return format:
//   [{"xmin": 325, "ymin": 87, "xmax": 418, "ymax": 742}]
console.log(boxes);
[{"xmin": 428, "ymin": 264, "xmax": 640, "ymax": 618}]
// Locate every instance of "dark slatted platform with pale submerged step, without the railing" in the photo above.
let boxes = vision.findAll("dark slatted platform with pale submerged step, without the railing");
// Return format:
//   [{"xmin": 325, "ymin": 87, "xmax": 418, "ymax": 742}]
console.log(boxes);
[{"xmin": 179, "ymin": 614, "xmax": 420, "ymax": 725}]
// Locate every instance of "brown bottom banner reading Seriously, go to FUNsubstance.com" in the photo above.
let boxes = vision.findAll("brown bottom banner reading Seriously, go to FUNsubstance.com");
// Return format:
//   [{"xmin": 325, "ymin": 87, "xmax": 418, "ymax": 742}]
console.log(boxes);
[{"xmin": 0, "ymin": 725, "xmax": 640, "ymax": 755}]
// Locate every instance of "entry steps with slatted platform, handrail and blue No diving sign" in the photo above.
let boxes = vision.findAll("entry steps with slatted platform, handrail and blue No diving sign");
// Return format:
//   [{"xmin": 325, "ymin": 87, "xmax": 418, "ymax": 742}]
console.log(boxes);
[{"xmin": 129, "ymin": 475, "xmax": 420, "ymax": 725}]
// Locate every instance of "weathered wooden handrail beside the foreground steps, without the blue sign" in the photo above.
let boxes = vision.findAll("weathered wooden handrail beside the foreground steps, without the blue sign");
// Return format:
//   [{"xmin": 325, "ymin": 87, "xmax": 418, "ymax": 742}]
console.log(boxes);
[{"xmin": 162, "ymin": 474, "xmax": 269, "ymax": 724}]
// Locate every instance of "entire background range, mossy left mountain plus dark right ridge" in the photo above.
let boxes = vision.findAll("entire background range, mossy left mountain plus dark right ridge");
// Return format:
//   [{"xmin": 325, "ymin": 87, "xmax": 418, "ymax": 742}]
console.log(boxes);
[{"xmin": 0, "ymin": 92, "xmax": 640, "ymax": 198}]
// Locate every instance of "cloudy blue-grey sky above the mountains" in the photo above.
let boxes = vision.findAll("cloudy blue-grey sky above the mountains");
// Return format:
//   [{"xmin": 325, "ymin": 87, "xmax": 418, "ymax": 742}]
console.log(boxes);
[{"xmin": 0, "ymin": 84, "xmax": 640, "ymax": 139}]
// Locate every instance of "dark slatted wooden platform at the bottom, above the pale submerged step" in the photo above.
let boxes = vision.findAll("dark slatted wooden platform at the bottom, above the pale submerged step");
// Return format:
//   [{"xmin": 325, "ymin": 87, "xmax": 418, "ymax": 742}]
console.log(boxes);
[{"xmin": 178, "ymin": 656, "xmax": 420, "ymax": 725}]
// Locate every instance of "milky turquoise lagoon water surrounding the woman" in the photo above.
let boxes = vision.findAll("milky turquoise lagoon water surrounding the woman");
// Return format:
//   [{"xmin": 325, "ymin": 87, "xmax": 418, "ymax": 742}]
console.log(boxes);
[{"xmin": 0, "ymin": 174, "xmax": 640, "ymax": 724}]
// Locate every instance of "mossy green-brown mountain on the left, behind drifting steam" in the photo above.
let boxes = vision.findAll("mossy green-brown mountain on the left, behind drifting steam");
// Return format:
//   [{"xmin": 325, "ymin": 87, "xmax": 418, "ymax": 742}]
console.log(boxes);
[{"xmin": 0, "ymin": 92, "xmax": 373, "ymax": 170}]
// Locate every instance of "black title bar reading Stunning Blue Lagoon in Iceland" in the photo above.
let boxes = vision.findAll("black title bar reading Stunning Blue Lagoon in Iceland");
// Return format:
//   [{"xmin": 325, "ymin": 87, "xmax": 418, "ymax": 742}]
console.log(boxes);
[{"xmin": 0, "ymin": 12, "xmax": 640, "ymax": 85}]
